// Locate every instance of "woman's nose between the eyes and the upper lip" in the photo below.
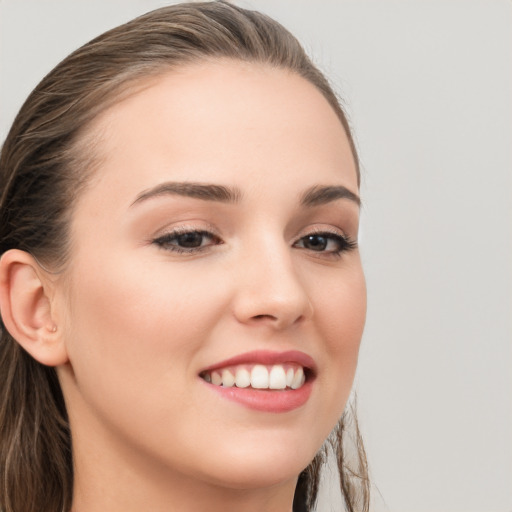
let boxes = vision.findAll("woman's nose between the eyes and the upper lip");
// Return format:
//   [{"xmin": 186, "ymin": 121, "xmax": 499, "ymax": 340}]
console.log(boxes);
[{"xmin": 234, "ymin": 241, "xmax": 313, "ymax": 330}]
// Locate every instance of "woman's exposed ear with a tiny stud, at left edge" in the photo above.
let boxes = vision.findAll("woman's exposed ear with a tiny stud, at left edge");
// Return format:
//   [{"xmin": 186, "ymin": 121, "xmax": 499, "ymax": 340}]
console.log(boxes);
[{"xmin": 0, "ymin": 249, "xmax": 68, "ymax": 366}]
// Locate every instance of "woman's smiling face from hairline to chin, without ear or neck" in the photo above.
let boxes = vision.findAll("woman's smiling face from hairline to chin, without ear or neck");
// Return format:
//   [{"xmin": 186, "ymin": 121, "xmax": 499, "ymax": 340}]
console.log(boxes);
[{"xmin": 58, "ymin": 62, "xmax": 366, "ymax": 488}]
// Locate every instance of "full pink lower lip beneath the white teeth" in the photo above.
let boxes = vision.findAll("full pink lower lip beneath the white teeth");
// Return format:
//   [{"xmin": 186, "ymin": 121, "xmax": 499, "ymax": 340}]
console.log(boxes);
[{"xmin": 201, "ymin": 379, "xmax": 313, "ymax": 413}]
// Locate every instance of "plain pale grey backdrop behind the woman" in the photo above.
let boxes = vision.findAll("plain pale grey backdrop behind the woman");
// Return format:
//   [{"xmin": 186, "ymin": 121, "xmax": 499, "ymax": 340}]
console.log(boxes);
[{"xmin": 0, "ymin": 0, "xmax": 512, "ymax": 512}]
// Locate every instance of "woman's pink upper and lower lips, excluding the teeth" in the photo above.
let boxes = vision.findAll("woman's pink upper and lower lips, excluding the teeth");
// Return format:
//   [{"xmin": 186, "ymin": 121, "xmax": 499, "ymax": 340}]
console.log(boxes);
[{"xmin": 200, "ymin": 350, "xmax": 317, "ymax": 413}]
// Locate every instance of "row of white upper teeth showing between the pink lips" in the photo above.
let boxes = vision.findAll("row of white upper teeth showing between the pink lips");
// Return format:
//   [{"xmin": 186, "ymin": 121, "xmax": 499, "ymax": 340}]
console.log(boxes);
[{"xmin": 201, "ymin": 364, "xmax": 306, "ymax": 389}]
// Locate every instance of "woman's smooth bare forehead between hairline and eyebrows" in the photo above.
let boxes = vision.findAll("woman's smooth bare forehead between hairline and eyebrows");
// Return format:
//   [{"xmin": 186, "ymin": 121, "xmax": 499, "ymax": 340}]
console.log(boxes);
[{"xmin": 82, "ymin": 61, "xmax": 357, "ymax": 201}]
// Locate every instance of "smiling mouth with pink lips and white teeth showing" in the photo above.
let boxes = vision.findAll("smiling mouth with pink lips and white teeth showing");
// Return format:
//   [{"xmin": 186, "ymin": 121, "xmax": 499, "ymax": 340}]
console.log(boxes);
[{"xmin": 199, "ymin": 351, "xmax": 316, "ymax": 412}]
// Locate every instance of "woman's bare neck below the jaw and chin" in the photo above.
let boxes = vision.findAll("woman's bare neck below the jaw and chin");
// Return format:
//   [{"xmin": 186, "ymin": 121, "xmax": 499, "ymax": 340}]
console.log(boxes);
[{"xmin": 72, "ymin": 416, "xmax": 297, "ymax": 512}]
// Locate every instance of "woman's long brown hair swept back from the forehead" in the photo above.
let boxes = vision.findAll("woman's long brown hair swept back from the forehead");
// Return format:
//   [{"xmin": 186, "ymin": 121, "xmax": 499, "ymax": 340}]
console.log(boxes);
[{"xmin": 0, "ymin": 1, "xmax": 369, "ymax": 512}]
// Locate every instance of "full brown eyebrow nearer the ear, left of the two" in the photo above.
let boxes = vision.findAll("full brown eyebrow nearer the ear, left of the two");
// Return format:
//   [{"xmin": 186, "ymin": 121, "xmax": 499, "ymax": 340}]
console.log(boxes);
[{"xmin": 131, "ymin": 181, "xmax": 242, "ymax": 206}]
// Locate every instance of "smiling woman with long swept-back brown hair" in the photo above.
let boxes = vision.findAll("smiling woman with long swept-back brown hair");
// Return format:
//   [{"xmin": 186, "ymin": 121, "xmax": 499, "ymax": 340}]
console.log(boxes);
[{"xmin": 0, "ymin": 2, "xmax": 368, "ymax": 512}]
